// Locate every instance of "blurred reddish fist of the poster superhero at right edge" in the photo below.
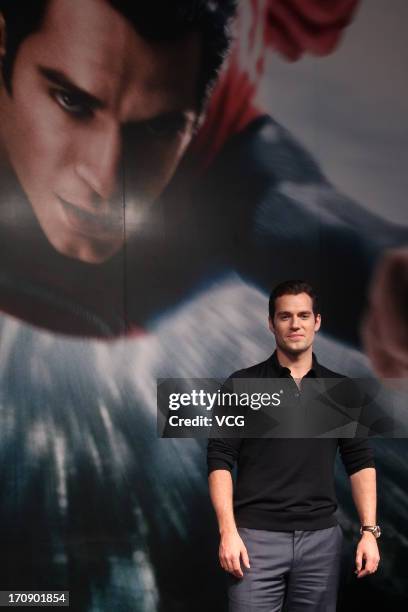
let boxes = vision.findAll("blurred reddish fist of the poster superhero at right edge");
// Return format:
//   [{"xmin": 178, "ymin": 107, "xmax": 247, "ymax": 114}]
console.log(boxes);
[{"xmin": 362, "ymin": 248, "xmax": 408, "ymax": 378}]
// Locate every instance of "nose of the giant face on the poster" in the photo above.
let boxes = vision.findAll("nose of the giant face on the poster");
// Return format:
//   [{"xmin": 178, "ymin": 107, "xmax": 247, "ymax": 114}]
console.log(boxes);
[{"xmin": 75, "ymin": 124, "xmax": 122, "ymax": 200}]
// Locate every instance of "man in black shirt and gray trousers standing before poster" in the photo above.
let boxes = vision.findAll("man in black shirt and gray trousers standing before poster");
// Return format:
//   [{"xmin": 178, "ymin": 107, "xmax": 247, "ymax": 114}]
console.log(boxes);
[{"xmin": 208, "ymin": 281, "xmax": 380, "ymax": 612}]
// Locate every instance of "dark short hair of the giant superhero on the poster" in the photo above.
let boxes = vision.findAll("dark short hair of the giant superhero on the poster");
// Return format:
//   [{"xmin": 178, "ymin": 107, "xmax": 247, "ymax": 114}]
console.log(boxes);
[{"xmin": 0, "ymin": 0, "xmax": 237, "ymax": 106}]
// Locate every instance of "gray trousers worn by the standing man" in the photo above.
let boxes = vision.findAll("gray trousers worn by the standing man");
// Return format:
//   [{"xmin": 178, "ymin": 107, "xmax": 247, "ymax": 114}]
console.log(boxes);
[{"xmin": 228, "ymin": 525, "xmax": 343, "ymax": 612}]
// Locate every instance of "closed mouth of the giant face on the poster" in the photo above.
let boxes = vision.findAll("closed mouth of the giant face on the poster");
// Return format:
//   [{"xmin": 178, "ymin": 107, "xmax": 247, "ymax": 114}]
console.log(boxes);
[{"xmin": 57, "ymin": 196, "xmax": 123, "ymax": 238}]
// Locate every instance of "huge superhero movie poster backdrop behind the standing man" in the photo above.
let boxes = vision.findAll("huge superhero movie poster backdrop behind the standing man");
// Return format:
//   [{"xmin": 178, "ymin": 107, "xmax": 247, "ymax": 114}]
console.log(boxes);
[{"xmin": 0, "ymin": 0, "xmax": 408, "ymax": 612}]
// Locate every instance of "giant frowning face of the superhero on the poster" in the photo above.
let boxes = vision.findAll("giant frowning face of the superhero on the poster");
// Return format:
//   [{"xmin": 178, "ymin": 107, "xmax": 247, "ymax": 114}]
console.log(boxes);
[{"xmin": 0, "ymin": 0, "xmax": 201, "ymax": 263}]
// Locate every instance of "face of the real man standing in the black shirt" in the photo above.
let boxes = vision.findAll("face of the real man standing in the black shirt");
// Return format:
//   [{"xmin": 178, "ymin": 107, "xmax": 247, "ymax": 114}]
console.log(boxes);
[{"xmin": 269, "ymin": 293, "xmax": 320, "ymax": 354}]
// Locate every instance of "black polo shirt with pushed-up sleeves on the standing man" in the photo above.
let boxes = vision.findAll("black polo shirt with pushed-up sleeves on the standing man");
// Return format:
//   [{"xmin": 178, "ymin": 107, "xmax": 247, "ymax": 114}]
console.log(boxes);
[{"xmin": 207, "ymin": 351, "xmax": 375, "ymax": 531}]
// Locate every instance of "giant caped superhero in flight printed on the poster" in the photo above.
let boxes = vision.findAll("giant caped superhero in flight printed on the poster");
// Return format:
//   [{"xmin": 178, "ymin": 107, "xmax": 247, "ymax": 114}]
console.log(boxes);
[{"xmin": 0, "ymin": 0, "xmax": 408, "ymax": 375}]
